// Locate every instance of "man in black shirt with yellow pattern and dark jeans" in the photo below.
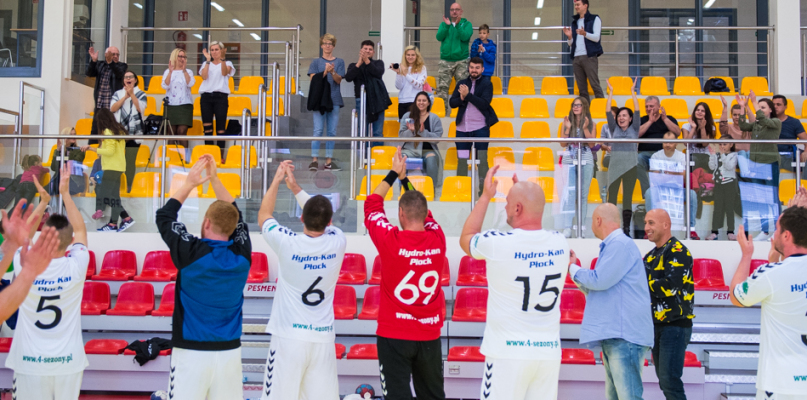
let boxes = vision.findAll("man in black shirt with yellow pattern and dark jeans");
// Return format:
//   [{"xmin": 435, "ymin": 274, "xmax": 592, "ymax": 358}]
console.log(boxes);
[{"xmin": 644, "ymin": 209, "xmax": 695, "ymax": 400}]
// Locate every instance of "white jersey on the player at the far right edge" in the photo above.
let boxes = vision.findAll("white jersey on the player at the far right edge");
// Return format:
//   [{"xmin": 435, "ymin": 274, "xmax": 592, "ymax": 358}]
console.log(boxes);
[{"xmin": 734, "ymin": 255, "xmax": 807, "ymax": 395}]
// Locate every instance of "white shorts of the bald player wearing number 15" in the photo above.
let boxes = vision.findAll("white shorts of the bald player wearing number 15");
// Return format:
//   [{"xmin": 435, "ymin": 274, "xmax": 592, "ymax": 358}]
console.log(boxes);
[{"xmin": 479, "ymin": 357, "xmax": 560, "ymax": 400}]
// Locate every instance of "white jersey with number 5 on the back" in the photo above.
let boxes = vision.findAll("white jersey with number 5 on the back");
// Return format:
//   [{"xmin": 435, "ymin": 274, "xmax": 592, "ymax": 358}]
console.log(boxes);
[{"xmin": 6, "ymin": 243, "xmax": 90, "ymax": 375}]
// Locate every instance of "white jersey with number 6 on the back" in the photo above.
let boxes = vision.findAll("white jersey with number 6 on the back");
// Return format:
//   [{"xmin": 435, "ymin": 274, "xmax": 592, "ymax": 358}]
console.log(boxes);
[{"xmin": 263, "ymin": 218, "xmax": 346, "ymax": 343}]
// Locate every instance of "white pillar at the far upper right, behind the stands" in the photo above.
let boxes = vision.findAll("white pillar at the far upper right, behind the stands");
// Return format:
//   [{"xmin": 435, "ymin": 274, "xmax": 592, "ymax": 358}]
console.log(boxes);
[{"xmin": 768, "ymin": 0, "xmax": 802, "ymax": 96}]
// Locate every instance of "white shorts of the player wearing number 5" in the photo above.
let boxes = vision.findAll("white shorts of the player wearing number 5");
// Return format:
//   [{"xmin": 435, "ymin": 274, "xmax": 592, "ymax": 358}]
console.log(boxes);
[{"xmin": 11, "ymin": 371, "xmax": 84, "ymax": 400}]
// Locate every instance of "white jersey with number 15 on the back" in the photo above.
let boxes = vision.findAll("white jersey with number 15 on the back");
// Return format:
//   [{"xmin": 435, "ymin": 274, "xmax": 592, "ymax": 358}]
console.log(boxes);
[{"xmin": 471, "ymin": 229, "xmax": 569, "ymax": 360}]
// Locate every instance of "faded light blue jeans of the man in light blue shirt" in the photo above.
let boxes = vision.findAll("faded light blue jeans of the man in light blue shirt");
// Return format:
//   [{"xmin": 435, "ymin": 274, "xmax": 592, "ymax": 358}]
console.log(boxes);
[{"xmin": 600, "ymin": 339, "xmax": 648, "ymax": 400}]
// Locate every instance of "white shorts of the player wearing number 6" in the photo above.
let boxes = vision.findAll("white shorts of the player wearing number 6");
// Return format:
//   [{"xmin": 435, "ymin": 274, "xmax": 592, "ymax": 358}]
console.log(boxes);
[{"xmin": 261, "ymin": 336, "xmax": 339, "ymax": 400}]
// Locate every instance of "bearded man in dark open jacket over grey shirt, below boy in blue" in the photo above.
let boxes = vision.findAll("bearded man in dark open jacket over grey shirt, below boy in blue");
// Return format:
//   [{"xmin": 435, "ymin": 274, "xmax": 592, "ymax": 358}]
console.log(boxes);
[{"xmin": 446, "ymin": 57, "xmax": 499, "ymax": 193}]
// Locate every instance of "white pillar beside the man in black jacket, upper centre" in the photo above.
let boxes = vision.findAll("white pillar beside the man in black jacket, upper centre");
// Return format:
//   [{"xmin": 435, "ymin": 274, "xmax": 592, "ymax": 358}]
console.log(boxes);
[{"xmin": 381, "ymin": 0, "xmax": 409, "ymax": 97}]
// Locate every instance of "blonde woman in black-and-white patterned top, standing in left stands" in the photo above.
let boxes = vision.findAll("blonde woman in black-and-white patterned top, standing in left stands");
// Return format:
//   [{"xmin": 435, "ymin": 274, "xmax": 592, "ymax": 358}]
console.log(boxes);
[{"xmin": 109, "ymin": 71, "xmax": 146, "ymax": 191}]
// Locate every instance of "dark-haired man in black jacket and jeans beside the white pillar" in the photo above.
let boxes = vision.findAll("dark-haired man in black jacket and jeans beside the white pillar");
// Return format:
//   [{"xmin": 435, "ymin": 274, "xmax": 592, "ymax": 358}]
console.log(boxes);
[{"xmin": 345, "ymin": 40, "xmax": 391, "ymax": 147}]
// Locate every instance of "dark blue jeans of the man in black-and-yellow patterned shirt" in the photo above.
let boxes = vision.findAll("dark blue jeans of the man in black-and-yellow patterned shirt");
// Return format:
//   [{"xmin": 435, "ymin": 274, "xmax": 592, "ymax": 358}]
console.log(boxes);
[{"xmin": 652, "ymin": 324, "xmax": 692, "ymax": 400}]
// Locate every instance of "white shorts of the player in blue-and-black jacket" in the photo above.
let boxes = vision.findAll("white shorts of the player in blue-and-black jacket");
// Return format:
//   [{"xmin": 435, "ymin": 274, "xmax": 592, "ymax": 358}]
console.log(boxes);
[{"xmin": 168, "ymin": 347, "xmax": 244, "ymax": 400}]
